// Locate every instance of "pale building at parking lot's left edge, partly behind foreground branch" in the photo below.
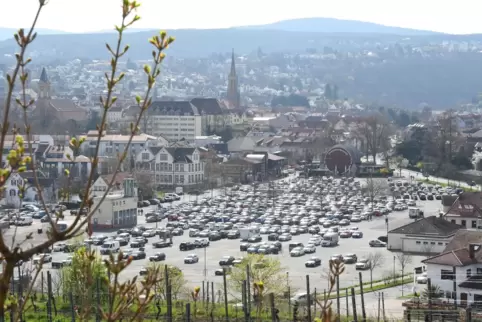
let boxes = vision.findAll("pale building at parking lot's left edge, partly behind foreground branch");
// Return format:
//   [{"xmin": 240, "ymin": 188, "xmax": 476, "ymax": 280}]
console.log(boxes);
[{"xmin": 91, "ymin": 173, "xmax": 138, "ymax": 231}]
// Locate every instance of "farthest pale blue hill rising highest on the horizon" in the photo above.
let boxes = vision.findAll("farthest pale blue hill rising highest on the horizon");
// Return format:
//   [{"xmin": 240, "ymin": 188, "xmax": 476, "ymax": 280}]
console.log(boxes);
[{"xmin": 239, "ymin": 18, "xmax": 444, "ymax": 36}]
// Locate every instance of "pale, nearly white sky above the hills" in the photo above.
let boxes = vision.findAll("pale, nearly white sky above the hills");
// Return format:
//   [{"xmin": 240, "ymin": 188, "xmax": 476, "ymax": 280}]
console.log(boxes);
[{"xmin": 0, "ymin": 0, "xmax": 482, "ymax": 34}]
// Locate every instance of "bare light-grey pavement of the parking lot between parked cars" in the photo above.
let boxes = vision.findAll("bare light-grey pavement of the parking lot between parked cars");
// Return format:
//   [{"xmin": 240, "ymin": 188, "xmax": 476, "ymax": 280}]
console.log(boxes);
[{"xmin": 5, "ymin": 180, "xmax": 441, "ymax": 292}]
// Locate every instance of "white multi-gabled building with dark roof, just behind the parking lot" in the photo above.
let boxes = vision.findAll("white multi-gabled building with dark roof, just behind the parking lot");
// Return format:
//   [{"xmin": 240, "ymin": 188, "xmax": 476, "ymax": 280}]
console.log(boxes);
[{"xmin": 136, "ymin": 147, "xmax": 205, "ymax": 187}]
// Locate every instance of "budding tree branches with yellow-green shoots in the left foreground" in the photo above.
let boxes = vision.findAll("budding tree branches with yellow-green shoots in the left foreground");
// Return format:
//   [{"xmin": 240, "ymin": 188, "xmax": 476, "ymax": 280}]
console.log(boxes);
[{"xmin": 0, "ymin": 0, "xmax": 174, "ymax": 321}]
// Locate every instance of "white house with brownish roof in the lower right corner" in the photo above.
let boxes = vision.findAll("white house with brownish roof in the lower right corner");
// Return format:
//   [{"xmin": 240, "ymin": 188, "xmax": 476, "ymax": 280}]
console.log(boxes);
[{"xmin": 423, "ymin": 230, "xmax": 482, "ymax": 307}]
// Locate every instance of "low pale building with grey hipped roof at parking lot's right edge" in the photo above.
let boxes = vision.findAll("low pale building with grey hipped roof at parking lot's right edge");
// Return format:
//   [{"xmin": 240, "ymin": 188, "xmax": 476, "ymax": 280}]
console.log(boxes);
[{"xmin": 387, "ymin": 216, "xmax": 461, "ymax": 255}]
